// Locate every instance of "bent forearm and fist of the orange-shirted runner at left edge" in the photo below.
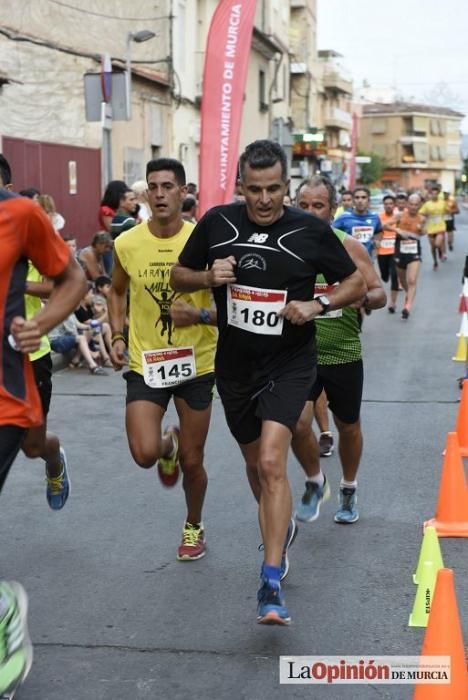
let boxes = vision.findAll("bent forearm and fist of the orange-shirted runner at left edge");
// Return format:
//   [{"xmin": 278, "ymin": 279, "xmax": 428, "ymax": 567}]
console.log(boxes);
[{"xmin": 10, "ymin": 258, "xmax": 86, "ymax": 353}]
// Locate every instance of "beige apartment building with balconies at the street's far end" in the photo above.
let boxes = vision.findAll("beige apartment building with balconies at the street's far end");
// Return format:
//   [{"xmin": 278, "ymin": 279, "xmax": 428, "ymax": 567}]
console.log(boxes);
[{"xmin": 359, "ymin": 102, "xmax": 464, "ymax": 192}]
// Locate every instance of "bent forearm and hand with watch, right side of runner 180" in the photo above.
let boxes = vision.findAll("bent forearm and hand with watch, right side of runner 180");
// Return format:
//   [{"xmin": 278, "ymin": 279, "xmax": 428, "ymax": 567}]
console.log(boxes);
[{"xmin": 278, "ymin": 268, "xmax": 367, "ymax": 326}]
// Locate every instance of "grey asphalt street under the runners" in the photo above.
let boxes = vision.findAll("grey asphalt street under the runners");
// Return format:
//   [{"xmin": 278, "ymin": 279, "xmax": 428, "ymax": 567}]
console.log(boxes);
[{"xmin": 0, "ymin": 212, "xmax": 468, "ymax": 700}]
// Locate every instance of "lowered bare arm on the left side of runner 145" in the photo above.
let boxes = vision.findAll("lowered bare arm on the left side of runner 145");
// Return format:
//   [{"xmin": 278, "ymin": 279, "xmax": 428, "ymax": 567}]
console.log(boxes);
[{"xmin": 107, "ymin": 248, "xmax": 130, "ymax": 371}]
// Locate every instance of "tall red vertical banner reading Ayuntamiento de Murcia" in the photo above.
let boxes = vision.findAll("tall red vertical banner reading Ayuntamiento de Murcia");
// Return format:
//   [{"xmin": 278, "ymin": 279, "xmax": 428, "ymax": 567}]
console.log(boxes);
[{"xmin": 199, "ymin": 0, "xmax": 256, "ymax": 214}]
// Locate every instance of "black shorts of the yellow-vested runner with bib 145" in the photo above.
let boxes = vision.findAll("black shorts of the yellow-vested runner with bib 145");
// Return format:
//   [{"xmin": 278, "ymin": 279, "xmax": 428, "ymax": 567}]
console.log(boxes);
[{"xmin": 123, "ymin": 370, "xmax": 214, "ymax": 411}]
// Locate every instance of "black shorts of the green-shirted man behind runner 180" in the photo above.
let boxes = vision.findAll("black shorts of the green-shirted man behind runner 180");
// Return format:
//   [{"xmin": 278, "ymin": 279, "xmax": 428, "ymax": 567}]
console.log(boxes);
[{"xmin": 308, "ymin": 360, "xmax": 364, "ymax": 423}]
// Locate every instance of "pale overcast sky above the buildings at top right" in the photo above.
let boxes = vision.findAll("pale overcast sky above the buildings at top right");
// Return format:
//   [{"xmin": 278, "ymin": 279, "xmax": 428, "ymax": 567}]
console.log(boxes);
[{"xmin": 317, "ymin": 0, "xmax": 468, "ymax": 133}]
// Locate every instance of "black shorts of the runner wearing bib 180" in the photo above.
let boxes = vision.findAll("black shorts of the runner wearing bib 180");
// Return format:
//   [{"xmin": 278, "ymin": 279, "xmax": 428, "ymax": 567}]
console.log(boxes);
[{"xmin": 216, "ymin": 360, "xmax": 316, "ymax": 445}]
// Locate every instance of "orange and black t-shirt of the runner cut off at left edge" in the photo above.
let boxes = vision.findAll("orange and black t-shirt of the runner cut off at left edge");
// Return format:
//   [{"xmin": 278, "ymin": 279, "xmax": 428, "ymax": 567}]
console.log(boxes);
[{"xmin": 0, "ymin": 194, "xmax": 70, "ymax": 428}]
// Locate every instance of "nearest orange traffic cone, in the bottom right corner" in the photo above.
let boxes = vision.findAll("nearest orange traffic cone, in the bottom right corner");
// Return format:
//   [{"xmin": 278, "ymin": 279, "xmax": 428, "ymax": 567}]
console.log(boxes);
[{"xmin": 413, "ymin": 569, "xmax": 468, "ymax": 700}]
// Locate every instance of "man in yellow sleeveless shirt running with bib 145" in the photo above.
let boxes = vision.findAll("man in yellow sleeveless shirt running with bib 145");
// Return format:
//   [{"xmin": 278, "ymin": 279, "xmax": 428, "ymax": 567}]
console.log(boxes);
[{"xmin": 108, "ymin": 158, "xmax": 217, "ymax": 561}]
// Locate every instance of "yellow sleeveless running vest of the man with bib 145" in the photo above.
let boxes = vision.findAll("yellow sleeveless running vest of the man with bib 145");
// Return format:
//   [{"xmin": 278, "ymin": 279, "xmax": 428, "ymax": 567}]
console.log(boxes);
[{"xmin": 114, "ymin": 222, "xmax": 217, "ymax": 376}]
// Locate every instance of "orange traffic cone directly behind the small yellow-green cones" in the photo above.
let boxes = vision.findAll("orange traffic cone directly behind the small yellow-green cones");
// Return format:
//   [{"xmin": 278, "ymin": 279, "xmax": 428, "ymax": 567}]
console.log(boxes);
[{"xmin": 424, "ymin": 432, "xmax": 468, "ymax": 537}]
